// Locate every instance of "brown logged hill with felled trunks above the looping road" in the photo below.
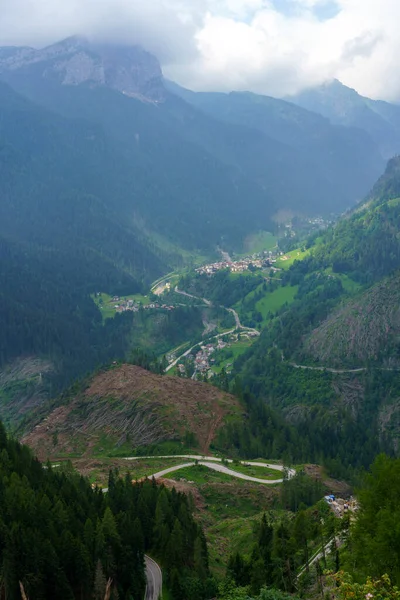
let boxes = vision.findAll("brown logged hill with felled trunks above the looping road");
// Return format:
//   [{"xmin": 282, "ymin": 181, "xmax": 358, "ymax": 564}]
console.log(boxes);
[{"xmin": 23, "ymin": 365, "xmax": 241, "ymax": 459}]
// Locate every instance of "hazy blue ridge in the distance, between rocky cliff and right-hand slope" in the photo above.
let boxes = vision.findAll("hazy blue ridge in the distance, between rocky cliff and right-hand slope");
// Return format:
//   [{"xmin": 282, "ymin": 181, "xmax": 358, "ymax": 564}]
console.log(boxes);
[{"xmin": 166, "ymin": 82, "xmax": 384, "ymax": 212}]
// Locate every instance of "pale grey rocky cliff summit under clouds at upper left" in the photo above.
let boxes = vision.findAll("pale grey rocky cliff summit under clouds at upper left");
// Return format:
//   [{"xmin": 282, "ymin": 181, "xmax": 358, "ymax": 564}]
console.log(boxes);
[{"xmin": 0, "ymin": 37, "xmax": 166, "ymax": 102}]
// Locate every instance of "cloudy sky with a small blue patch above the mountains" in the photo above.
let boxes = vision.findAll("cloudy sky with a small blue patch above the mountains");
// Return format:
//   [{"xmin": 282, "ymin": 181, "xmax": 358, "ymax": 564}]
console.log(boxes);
[{"xmin": 0, "ymin": 0, "xmax": 400, "ymax": 100}]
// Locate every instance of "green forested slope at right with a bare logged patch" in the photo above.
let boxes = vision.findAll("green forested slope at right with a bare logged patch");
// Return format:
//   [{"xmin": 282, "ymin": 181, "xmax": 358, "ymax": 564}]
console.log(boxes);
[{"xmin": 236, "ymin": 159, "xmax": 400, "ymax": 474}]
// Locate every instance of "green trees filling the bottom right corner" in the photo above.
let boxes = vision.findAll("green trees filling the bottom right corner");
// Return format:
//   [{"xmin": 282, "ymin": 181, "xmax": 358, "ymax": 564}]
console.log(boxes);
[{"xmin": 219, "ymin": 455, "xmax": 400, "ymax": 600}]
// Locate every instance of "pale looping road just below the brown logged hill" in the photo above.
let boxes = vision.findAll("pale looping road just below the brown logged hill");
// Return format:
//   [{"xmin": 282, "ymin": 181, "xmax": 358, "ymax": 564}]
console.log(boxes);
[{"xmin": 124, "ymin": 454, "xmax": 296, "ymax": 485}]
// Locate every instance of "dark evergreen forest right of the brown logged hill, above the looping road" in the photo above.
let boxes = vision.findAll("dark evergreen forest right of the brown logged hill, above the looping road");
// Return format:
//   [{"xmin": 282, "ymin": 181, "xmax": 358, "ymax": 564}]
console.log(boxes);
[{"xmin": 213, "ymin": 380, "xmax": 384, "ymax": 480}]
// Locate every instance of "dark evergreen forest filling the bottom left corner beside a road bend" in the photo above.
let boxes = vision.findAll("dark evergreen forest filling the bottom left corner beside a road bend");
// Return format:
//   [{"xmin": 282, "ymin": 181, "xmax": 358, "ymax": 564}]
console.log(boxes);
[{"xmin": 0, "ymin": 425, "xmax": 213, "ymax": 600}]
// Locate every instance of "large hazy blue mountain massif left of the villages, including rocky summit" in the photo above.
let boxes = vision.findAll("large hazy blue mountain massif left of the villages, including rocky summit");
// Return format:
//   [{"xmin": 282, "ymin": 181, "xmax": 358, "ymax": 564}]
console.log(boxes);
[{"xmin": 0, "ymin": 38, "xmax": 394, "ymax": 401}]
